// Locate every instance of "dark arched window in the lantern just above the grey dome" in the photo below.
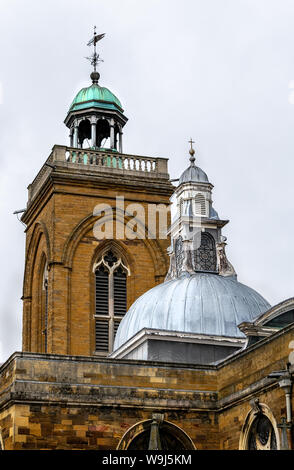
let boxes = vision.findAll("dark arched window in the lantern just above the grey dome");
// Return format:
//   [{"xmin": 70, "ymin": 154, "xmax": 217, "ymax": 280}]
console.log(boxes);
[{"xmin": 194, "ymin": 232, "xmax": 216, "ymax": 272}]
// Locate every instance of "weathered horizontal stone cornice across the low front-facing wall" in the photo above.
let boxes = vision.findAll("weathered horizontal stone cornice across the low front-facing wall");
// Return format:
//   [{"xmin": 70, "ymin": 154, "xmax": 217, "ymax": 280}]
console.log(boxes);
[{"xmin": 0, "ymin": 380, "xmax": 217, "ymax": 410}]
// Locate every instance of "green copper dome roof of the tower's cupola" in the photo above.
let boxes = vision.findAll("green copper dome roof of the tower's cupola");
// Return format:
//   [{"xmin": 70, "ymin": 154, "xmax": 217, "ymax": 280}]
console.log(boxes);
[{"xmin": 69, "ymin": 83, "xmax": 123, "ymax": 112}]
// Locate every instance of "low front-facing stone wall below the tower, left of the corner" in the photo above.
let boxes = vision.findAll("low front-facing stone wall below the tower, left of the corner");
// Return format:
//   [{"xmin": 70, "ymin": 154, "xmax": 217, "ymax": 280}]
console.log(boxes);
[{"xmin": 0, "ymin": 353, "xmax": 218, "ymax": 449}]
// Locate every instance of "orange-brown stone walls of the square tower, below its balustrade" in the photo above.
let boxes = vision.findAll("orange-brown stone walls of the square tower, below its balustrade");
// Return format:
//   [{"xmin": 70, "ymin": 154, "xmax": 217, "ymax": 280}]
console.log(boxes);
[{"xmin": 23, "ymin": 164, "xmax": 172, "ymax": 355}]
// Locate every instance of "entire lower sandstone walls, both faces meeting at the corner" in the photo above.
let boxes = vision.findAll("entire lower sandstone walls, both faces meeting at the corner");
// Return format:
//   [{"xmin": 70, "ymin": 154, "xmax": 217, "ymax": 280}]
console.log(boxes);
[{"xmin": 0, "ymin": 326, "xmax": 294, "ymax": 450}]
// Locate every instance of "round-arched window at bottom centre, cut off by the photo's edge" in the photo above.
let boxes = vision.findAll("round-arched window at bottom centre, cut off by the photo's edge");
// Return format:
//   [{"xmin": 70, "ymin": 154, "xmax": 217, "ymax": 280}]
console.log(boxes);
[{"xmin": 117, "ymin": 419, "xmax": 196, "ymax": 451}]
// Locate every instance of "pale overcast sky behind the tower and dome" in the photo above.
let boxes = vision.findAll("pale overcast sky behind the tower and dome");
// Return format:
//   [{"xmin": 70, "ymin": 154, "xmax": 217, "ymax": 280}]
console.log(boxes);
[{"xmin": 0, "ymin": 0, "xmax": 294, "ymax": 362}]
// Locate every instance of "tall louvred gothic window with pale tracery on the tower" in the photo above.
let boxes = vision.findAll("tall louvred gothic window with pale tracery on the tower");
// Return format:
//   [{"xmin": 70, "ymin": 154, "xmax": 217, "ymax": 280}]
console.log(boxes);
[{"xmin": 94, "ymin": 250, "xmax": 129, "ymax": 354}]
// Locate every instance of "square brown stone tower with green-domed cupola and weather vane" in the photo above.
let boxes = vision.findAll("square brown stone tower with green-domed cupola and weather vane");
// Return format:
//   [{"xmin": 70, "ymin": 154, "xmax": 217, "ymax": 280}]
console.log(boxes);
[{"xmin": 22, "ymin": 32, "xmax": 173, "ymax": 356}]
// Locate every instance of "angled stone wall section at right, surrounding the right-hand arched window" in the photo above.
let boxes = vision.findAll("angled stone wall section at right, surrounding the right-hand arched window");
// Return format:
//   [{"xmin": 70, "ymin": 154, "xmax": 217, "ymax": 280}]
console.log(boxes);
[{"xmin": 218, "ymin": 325, "xmax": 294, "ymax": 449}]
